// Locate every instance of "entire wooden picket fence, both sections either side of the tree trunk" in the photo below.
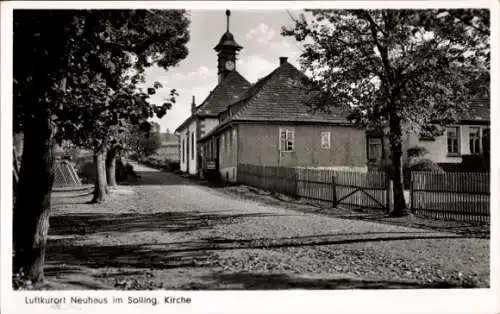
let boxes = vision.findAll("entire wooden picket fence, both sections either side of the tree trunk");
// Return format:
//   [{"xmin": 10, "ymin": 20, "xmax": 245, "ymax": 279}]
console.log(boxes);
[{"xmin": 237, "ymin": 164, "xmax": 490, "ymax": 223}]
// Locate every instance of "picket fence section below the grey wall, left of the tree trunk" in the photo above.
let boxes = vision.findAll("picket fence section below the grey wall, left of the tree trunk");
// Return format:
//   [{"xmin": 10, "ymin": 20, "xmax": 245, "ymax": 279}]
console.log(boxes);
[{"xmin": 237, "ymin": 164, "xmax": 386, "ymax": 209}]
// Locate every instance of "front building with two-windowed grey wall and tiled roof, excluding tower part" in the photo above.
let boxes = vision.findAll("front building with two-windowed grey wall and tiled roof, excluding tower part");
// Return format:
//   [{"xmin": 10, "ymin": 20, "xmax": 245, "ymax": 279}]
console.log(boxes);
[{"xmin": 199, "ymin": 57, "xmax": 367, "ymax": 181}]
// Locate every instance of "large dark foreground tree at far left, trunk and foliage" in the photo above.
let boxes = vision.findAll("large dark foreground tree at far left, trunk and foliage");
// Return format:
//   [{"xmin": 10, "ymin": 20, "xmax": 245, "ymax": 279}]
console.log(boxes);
[{"xmin": 13, "ymin": 10, "xmax": 189, "ymax": 283}]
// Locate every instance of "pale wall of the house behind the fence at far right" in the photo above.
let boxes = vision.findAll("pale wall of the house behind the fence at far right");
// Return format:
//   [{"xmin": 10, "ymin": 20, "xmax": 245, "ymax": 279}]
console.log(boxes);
[{"xmin": 403, "ymin": 125, "xmax": 486, "ymax": 163}]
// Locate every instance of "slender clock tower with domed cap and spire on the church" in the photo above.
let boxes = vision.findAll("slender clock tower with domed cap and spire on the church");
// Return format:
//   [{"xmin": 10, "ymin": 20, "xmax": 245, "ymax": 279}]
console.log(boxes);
[{"xmin": 214, "ymin": 10, "xmax": 243, "ymax": 83}]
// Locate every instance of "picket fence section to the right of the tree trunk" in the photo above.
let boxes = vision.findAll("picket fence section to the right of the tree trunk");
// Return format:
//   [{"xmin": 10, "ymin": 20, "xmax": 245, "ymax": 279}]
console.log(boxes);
[{"xmin": 410, "ymin": 172, "xmax": 490, "ymax": 223}]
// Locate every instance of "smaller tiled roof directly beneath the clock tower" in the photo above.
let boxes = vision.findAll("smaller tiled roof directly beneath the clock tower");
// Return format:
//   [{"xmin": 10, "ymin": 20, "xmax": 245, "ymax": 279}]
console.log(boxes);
[{"xmin": 195, "ymin": 71, "xmax": 251, "ymax": 116}]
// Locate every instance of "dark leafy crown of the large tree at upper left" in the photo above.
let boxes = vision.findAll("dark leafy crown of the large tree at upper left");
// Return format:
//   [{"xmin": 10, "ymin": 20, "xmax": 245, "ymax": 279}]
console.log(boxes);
[{"xmin": 14, "ymin": 10, "xmax": 189, "ymax": 148}]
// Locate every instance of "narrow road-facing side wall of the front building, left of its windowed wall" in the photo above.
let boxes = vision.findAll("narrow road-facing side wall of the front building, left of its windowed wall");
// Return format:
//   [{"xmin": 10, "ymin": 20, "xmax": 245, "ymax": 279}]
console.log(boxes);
[{"xmin": 219, "ymin": 128, "xmax": 238, "ymax": 182}]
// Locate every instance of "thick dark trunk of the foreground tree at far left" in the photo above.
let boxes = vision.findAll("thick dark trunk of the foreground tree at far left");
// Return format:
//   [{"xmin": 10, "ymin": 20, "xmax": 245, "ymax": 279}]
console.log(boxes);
[{"xmin": 13, "ymin": 111, "xmax": 55, "ymax": 283}]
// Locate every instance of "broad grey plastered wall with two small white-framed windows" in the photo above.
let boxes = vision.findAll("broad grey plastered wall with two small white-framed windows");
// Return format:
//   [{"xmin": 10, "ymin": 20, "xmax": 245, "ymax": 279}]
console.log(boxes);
[{"xmin": 237, "ymin": 124, "xmax": 367, "ymax": 170}]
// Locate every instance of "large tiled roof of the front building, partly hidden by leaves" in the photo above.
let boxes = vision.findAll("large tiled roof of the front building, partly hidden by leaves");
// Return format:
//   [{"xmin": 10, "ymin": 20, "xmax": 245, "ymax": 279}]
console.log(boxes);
[{"xmin": 230, "ymin": 62, "xmax": 348, "ymax": 124}]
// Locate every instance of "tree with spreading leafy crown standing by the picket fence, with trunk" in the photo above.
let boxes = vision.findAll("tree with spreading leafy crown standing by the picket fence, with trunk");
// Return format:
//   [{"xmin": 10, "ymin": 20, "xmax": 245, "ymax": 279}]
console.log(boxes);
[{"xmin": 282, "ymin": 9, "xmax": 490, "ymax": 216}]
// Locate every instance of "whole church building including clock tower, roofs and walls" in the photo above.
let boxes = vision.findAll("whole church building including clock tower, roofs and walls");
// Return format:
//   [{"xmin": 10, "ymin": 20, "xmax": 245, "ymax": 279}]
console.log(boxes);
[{"xmin": 177, "ymin": 11, "xmax": 367, "ymax": 182}]
